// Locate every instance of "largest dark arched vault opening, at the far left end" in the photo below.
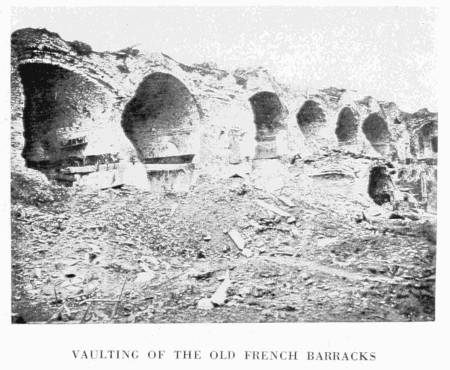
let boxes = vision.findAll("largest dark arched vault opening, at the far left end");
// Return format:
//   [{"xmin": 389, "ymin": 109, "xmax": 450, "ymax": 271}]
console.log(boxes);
[{"xmin": 19, "ymin": 63, "xmax": 109, "ymax": 170}]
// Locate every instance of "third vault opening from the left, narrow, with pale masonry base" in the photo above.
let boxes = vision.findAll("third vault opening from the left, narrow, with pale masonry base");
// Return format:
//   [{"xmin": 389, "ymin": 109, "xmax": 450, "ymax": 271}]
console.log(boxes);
[{"xmin": 249, "ymin": 91, "xmax": 288, "ymax": 159}]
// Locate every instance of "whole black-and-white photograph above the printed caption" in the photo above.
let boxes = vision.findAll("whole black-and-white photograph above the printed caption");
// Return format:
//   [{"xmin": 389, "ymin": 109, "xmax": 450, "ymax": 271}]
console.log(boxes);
[{"xmin": 10, "ymin": 4, "xmax": 440, "ymax": 325}]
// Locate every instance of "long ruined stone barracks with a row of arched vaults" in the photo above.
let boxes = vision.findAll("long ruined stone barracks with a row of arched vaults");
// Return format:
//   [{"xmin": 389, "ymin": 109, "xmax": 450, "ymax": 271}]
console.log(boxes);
[{"xmin": 11, "ymin": 28, "xmax": 438, "ymax": 210}]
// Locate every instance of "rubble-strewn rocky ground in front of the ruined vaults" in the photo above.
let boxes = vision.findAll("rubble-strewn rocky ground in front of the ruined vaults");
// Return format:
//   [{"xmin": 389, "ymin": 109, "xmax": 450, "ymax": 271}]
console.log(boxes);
[{"xmin": 11, "ymin": 159, "xmax": 435, "ymax": 323}]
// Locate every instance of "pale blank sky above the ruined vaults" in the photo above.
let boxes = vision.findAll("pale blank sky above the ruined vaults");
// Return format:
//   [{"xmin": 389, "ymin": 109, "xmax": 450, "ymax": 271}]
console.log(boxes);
[{"xmin": 11, "ymin": 7, "xmax": 438, "ymax": 112}]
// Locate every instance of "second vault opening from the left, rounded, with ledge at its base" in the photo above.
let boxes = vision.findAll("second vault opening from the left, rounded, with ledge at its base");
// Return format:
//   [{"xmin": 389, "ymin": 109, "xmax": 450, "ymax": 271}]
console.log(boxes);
[{"xmin": 122, "ymin": 72, "xmax": 200, "ymax": 163}]
